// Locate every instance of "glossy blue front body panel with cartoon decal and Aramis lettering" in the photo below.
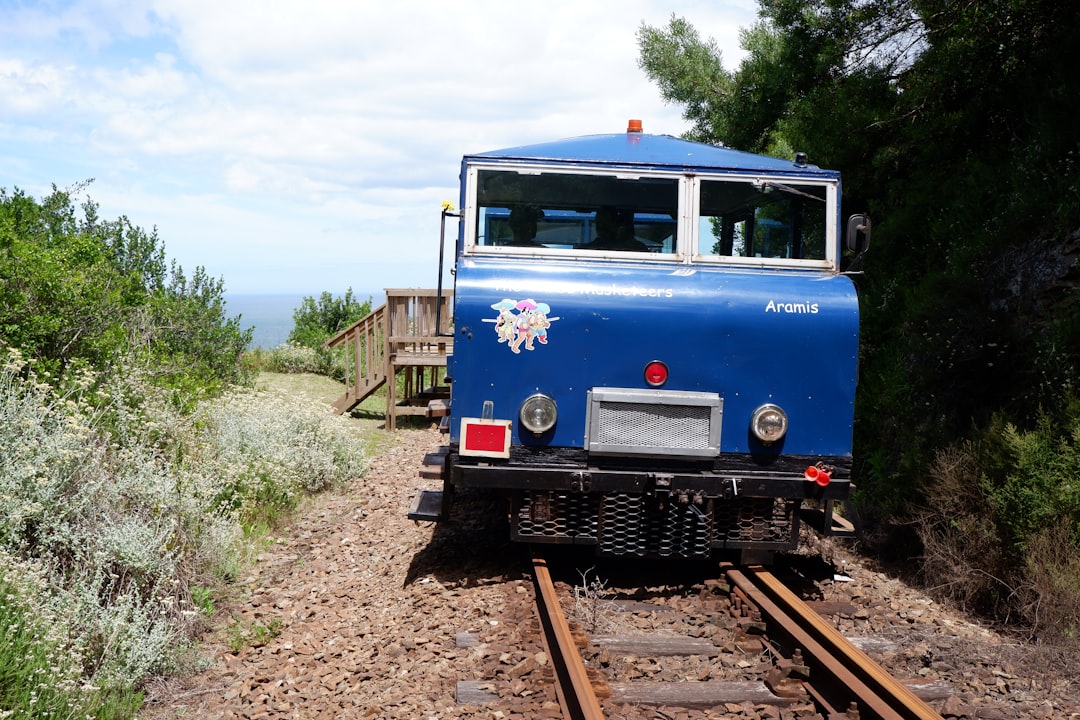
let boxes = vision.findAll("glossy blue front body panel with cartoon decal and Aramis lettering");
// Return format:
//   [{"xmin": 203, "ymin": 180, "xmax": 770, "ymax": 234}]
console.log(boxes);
[{"xmin": 450, "ymin": 259, "xmax": 859, "ymax": 456}]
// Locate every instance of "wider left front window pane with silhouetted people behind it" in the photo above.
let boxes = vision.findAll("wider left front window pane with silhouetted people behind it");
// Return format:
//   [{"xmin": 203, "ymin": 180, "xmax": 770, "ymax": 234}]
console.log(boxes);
[{"xmin": 475, "ymin": 168, "xmax": 679, "ymax": 256}]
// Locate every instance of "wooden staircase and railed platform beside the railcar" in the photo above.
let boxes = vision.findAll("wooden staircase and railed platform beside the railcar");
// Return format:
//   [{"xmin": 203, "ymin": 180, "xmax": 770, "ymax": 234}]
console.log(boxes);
[{"xmin": 323, "ymin": 288, "xmax": 454, "ymax": 430}]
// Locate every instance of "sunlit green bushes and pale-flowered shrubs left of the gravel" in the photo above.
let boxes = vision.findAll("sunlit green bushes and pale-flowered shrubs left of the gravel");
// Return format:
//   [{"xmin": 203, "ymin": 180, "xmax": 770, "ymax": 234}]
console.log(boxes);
[{"xmin": 0, "ymin": 189, "xmax": 365, "ymax": 720}]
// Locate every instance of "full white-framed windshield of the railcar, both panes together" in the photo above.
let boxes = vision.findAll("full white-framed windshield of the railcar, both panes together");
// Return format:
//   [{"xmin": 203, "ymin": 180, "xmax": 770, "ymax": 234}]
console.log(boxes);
[{"xmin": 469, "ymin": 166, "xmax": 837, "ymax": 268}]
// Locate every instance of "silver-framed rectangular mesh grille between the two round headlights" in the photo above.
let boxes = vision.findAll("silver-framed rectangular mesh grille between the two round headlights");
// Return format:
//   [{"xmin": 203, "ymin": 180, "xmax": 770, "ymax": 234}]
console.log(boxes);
[{"xmin": 588, "ymin": 388, "xmax": 721, "ymax": 457}]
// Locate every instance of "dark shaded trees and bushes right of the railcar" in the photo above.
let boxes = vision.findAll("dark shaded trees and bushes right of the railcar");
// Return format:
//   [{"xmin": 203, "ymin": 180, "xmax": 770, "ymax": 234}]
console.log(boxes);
[{"xmin": 638, "ymin": 0, "xmax": 1080, "ymax": 639}]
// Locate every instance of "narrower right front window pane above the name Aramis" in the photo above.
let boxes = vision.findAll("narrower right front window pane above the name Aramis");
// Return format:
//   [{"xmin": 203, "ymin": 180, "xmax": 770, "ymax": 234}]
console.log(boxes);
[{"xmin": 697, "ymin": 179, "xmax": 827, "ymax": 260}]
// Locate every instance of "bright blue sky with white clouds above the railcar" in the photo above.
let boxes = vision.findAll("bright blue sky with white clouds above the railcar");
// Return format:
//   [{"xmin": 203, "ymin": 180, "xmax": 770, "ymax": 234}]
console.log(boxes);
[{"xmin": 0, "ymin": 0, "xmax": 757, "ymax": 297}]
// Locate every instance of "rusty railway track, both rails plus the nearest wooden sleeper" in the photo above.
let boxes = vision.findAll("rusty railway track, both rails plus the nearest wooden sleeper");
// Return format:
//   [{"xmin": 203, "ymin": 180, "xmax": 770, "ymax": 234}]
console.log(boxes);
[{"xmin": 532, "ymin": 551, "xmax": 942, "ymax": 720}]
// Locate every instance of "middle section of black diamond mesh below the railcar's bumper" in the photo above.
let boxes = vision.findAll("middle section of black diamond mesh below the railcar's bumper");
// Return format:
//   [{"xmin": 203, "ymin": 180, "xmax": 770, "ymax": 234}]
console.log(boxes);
[{"xmin": 599, "ymin": 494, "xmax": 713, "ymax": 557}]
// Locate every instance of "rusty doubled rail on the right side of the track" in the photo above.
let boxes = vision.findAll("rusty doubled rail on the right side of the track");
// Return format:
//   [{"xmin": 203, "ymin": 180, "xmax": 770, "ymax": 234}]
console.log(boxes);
[{"xmin": 724, "ymin": 563, "xmax": 943, "ymax": 720}]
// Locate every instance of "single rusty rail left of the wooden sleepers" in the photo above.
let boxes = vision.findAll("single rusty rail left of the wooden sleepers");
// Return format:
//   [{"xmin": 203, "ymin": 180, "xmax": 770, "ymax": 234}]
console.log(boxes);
[{"xmin": 532, "ymin": 549, "xmax": 604, "ymax": 720}]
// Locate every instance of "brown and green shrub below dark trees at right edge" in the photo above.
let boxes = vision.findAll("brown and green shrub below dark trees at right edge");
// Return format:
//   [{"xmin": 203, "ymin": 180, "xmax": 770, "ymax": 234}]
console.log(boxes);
[{"xmin": 915, "ymin": 413, "xmax": 1080, "ymax": 642}]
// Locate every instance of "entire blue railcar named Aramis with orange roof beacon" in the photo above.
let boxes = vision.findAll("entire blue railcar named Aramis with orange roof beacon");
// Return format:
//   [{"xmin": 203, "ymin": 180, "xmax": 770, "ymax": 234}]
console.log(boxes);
[{"xmin": 409, "ymin": 121, "xmax": 869, "ymax": 559}]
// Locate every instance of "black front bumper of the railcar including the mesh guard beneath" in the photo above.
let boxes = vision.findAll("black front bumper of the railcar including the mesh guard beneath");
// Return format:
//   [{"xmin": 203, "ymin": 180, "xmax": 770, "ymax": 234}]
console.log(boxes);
[{"xmin": 447, "ymin": 453, "xmax": 850, "ymax": 557}]
